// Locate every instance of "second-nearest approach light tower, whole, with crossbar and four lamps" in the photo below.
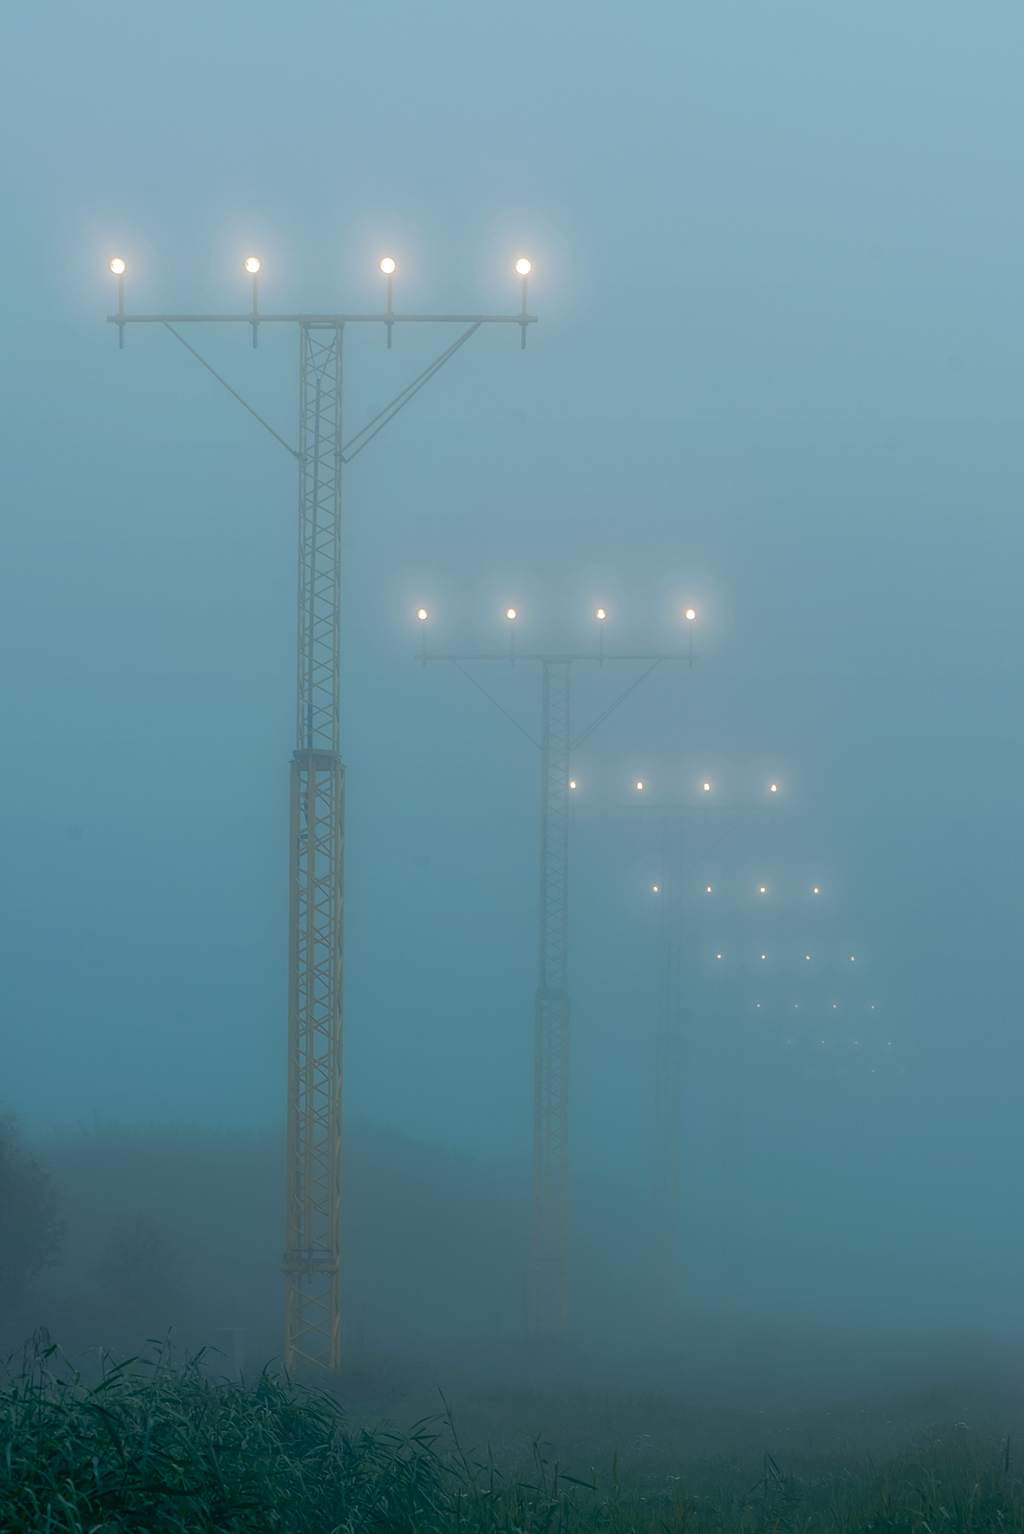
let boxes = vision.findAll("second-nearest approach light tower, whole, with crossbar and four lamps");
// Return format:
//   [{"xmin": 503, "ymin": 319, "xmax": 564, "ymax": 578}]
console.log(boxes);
[{"xmin": 417, "ymin": 607, "xmax": 696, "ymax": 1338}]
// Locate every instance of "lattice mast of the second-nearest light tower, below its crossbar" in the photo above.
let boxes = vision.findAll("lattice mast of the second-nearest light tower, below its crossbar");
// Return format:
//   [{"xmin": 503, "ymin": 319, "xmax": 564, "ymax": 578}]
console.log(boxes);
[{"xmin": 532, "ymin": 660, "xmax": 569, "ymax": 1333}]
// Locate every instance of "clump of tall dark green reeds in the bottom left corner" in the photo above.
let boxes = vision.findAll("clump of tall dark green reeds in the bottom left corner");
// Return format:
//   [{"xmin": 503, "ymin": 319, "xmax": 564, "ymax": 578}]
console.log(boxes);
[{"xmin": 0, "ymin": 1348, "xmax": 462, "ymax": 1534}]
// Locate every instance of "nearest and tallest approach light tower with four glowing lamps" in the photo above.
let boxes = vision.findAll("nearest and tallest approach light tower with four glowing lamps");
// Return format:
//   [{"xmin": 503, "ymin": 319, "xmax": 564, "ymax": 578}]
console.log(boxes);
[{"xmin": 107, "ymin": 256, "xmax": 537, "ymax": 1370}]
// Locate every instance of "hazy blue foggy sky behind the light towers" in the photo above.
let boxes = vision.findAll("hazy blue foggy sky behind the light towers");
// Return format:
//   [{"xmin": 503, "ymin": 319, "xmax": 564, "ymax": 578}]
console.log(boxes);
[{"xmin": 0, "ymin": 0, "xmax": 1024, "ymax": 1368}]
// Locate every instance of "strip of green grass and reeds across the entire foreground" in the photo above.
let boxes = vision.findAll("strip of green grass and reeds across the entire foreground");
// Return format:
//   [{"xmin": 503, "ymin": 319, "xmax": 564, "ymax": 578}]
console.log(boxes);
[{"xmin": 0, "ymin": 1348, "xmax": 1024, "ymax": 1534}]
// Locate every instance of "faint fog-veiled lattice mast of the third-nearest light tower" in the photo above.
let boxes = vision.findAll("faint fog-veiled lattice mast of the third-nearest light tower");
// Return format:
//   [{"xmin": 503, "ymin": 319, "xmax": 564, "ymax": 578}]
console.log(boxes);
[{"xmin": 653, "ymin": 811, "xmax": 684, "ymax": 1299}]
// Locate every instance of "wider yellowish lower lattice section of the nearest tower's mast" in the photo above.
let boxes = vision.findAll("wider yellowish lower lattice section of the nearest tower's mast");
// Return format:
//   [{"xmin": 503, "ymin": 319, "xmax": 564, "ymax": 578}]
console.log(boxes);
[{"xmin": 284, "ymin": 752, "xmax": 345, "ymax": 1368}]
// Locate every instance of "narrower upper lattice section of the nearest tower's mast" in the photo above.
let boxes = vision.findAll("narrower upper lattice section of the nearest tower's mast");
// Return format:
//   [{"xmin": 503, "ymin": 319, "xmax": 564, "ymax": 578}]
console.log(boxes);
[{"xmin": 296, "ymin": 325, "xmax": 343, "ymax": 752}]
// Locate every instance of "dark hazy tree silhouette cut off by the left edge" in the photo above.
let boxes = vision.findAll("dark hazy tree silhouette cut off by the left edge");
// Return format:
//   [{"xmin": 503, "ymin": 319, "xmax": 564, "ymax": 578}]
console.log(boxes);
[{"xmin": 0, "ymin": 1114, "xmax": 63, "ymax": 1310}]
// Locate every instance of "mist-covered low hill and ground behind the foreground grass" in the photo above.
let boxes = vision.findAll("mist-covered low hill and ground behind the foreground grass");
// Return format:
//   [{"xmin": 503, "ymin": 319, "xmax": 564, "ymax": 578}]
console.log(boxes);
[{"xmin": 2, "ymin": 1124, "xmax": 1024, "ymax": 1496}]
